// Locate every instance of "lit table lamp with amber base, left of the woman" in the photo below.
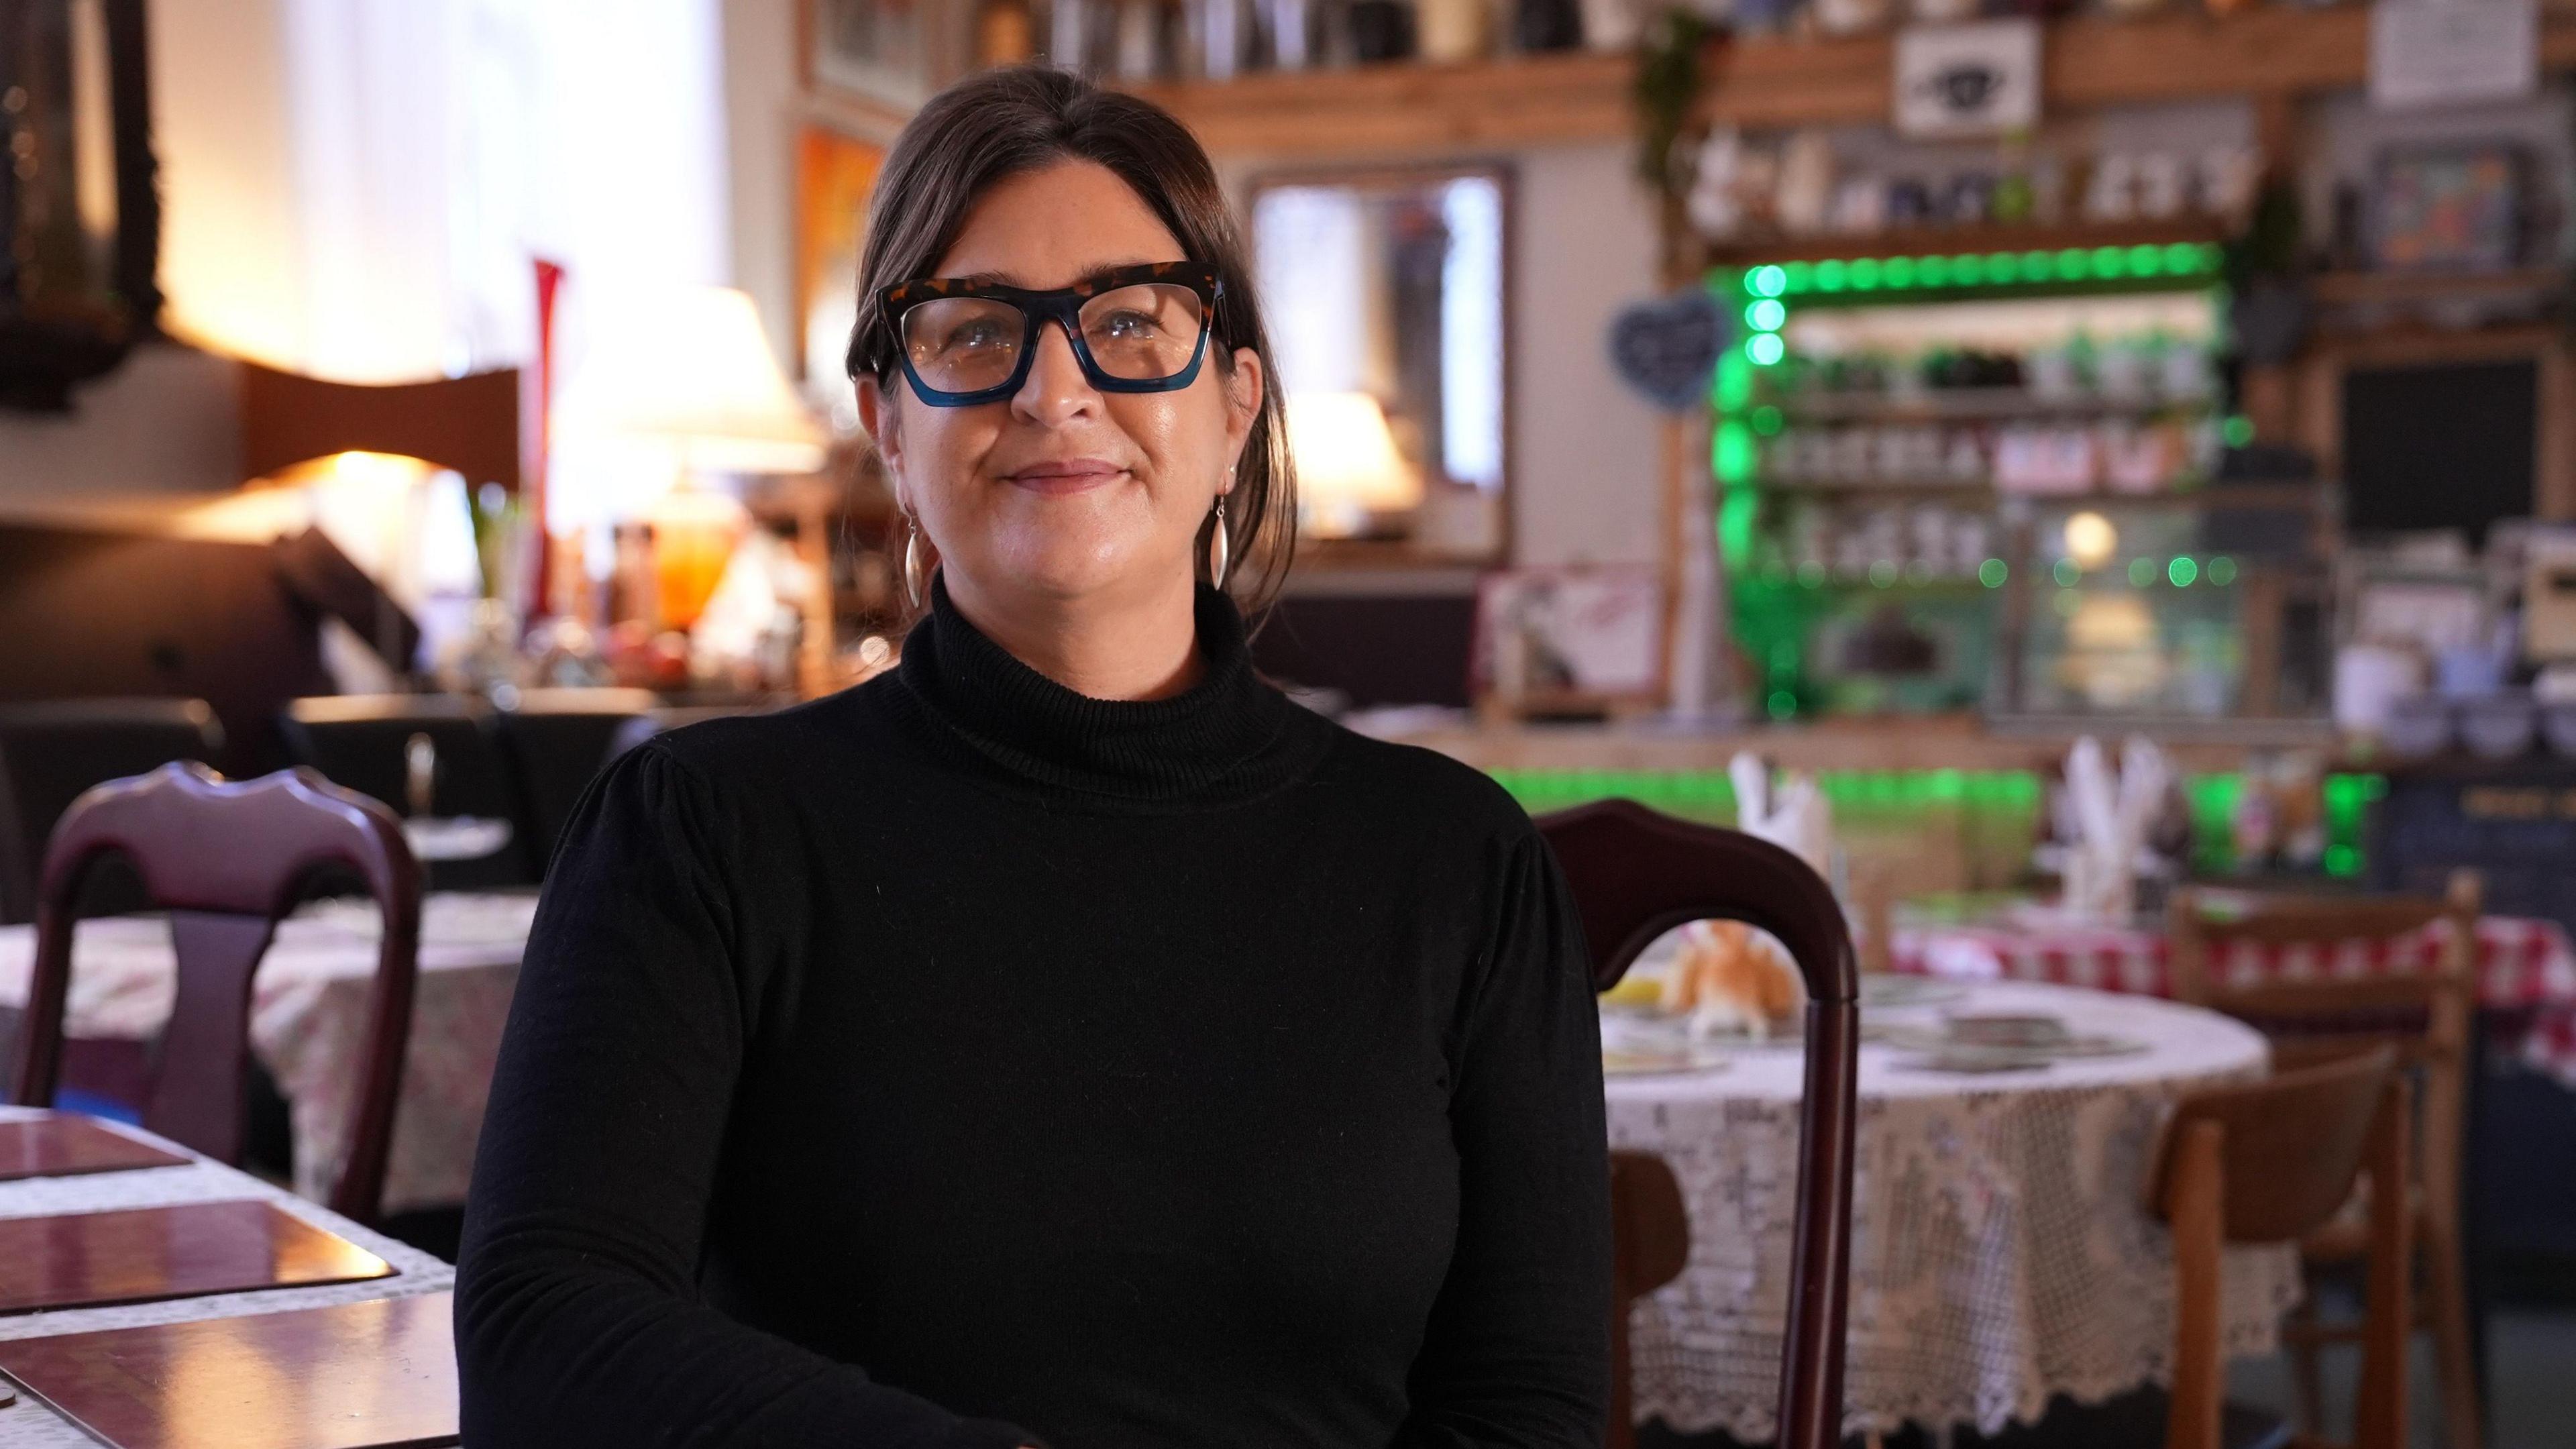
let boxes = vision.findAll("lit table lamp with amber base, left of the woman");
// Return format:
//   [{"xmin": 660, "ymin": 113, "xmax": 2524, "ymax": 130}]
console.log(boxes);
[{"xmin": 561, "ymin": 286, "xmax": 824, "ymax": 629}]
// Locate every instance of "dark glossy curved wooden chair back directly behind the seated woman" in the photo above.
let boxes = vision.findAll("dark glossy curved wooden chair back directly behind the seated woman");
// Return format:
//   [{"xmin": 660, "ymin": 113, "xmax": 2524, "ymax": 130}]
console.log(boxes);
[{"xmin": 1538, "ymin": 799, "xmax": 1860, "ymax": 1449}]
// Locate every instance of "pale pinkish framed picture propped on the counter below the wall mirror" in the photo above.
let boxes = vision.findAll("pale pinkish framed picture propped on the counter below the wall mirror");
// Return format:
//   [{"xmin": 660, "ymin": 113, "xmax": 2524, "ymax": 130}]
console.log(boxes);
[{"xmin": 1471, "ymin": 565, "xmax": 1664, "ymax": 712}]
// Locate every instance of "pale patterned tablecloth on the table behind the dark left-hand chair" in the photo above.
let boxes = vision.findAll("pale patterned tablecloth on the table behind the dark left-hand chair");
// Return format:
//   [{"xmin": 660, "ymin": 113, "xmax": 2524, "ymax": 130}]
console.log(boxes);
[{"xmin": 0, "ymin": 892, "xmax": 536, "ymax": 1212}]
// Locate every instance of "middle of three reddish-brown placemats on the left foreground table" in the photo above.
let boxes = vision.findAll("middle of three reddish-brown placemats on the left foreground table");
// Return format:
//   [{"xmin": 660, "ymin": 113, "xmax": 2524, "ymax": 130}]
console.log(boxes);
[{"xmin": 0, "ymin": 1199, "xmax": 394, "ymax": 1312}]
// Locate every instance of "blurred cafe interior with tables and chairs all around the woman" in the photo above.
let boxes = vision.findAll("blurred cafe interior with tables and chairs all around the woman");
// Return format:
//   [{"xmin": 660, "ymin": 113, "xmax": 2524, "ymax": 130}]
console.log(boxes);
[{"xmin": 0, "ymin": 0, "xmax": 2576, "ymax": 1449}]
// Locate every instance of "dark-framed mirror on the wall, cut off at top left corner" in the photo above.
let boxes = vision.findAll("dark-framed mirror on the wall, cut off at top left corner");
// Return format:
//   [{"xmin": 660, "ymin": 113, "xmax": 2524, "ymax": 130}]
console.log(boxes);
[{"xmin": 0, "ymin": 0, "xmax": 160, "ymax": 413}]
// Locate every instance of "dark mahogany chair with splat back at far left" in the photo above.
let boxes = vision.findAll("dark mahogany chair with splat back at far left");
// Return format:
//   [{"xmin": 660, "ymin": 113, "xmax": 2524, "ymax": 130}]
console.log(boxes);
[{"xmin": 10, "ymin": 763, "xmax": 420, "ymax": 1222}]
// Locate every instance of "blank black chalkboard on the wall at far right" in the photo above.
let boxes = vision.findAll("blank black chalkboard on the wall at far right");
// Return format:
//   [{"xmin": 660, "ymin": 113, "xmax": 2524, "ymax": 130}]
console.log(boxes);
[{"xmin": 2344, "ymin": 358, "xmax": 2540, "ymax": 544}]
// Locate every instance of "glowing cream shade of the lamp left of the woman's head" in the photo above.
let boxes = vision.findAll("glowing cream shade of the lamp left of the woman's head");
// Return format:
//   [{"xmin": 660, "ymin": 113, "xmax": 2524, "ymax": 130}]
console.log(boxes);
[{"xmin": 559, "ymin": 286, "xmax": 824, "ymax": 472}]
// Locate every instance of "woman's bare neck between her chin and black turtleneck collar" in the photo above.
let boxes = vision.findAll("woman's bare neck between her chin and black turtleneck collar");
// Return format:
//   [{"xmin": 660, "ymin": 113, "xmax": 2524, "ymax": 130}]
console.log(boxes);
[{"xmin": 941, "ymin": 568, "xmax": 1203, "ymax": 699}]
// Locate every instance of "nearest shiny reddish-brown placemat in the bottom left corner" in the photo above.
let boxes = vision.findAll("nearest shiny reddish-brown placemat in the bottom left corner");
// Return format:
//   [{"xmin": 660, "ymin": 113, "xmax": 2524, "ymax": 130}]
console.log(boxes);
[{"xmin": 0, "ymin": 1294, "xmax": 459, "ymax": 1449}]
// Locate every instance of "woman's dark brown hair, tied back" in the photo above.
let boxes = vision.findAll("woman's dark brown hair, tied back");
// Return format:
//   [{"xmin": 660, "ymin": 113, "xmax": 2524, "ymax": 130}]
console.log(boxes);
[{"xmin": 847, "ymin": 64, "xmax": 1296, "ymax": 614}]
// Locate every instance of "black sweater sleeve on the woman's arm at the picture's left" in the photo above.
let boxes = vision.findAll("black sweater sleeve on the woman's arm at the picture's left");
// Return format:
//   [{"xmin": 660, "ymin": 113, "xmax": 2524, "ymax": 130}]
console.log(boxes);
[{"xmin": 456, "ymin": 745, "xmax": 1036, "ymax": 1449}]
